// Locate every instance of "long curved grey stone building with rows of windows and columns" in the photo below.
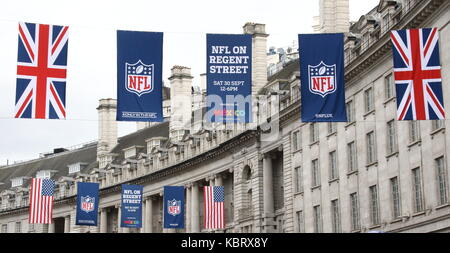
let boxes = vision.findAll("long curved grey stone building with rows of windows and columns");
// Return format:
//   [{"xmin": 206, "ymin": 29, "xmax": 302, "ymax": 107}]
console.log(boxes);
[{"xmin": 0, "ymin": 0, "xmax": 450, "ymax": 233}]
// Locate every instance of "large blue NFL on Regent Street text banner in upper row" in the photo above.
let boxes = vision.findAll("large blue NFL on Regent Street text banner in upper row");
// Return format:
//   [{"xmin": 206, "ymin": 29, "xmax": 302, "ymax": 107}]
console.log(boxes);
[{"xmin": 206, "ymin": 34, "xmax": 252, "ymax": 123}]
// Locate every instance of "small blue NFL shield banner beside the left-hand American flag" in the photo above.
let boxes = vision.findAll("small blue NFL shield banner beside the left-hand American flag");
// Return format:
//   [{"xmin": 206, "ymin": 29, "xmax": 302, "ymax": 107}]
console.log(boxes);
[{"xmin": 75, "ymin": 182, "xmax": 99, "ymax": 226}]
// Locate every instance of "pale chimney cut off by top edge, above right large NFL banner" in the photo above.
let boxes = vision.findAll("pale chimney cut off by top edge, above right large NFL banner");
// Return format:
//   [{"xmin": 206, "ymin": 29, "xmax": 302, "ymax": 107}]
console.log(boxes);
[{"xmin": 319, "ymin": 0, "xmax": 350, "ymax": 33}]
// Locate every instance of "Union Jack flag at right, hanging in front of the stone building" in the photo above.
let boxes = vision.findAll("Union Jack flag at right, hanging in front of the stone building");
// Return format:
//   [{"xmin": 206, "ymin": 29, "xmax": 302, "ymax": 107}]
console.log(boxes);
[{"xmin": 391, "ymin": 28, "xmax": 445, "ymax": 120}]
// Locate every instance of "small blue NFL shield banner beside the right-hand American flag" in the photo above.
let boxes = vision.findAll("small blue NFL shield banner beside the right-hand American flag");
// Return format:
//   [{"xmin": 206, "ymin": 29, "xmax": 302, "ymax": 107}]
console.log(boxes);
[{"xmin": 164, "ymin": 186, "xmax": 184, "ymax": 228}]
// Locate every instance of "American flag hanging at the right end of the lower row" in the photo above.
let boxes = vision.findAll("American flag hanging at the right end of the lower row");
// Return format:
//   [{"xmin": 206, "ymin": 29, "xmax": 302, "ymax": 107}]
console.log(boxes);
[{"xmin": 204, "ymin": 186, "xmax": 225, "ymax": 229}]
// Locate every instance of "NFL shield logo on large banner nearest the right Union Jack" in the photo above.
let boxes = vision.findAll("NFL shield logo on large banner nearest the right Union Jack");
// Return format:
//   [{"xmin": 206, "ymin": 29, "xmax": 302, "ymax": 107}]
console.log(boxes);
[{"xmin": 308, "ymin": 61, "xmax": 336, "ymax": 97}]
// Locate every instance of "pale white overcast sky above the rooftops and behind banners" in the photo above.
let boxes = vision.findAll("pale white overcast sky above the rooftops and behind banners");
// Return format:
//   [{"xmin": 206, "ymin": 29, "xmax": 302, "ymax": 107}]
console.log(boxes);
[{"xmin": 0, "ymin": 0, "xmax": 379, "ymax": 165}]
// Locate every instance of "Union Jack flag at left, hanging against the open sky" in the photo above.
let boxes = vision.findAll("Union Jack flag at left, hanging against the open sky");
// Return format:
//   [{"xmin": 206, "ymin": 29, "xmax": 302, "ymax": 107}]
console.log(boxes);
[{"xmin": 15, "ymin": 22, "xmax": 69, "ymax": 119}]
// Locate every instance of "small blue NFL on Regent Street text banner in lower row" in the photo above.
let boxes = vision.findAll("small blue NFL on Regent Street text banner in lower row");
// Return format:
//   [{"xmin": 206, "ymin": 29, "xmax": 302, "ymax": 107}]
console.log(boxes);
[{"xmin": 120, "ymin": 184, "xmax": 144, "ymax": 228}]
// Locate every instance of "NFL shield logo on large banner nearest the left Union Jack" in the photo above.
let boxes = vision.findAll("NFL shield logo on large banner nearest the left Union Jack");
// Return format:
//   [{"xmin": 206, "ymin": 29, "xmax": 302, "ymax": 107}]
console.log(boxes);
[{"xmin": 125, "ymin": 60, "xmax": 154, "ymax": 97}]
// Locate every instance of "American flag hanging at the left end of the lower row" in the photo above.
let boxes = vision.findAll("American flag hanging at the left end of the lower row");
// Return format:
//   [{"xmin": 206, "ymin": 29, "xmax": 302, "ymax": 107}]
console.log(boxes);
[{"xmin": 28, "ymin": 178, "xmax": 55, "ymax": 224}]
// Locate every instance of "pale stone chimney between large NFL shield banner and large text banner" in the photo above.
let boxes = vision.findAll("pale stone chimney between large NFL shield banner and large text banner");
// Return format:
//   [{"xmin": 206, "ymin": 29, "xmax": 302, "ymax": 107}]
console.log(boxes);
[{"xmin": 169, "ymin": 66, "xmax": 193, "ymax": 141}]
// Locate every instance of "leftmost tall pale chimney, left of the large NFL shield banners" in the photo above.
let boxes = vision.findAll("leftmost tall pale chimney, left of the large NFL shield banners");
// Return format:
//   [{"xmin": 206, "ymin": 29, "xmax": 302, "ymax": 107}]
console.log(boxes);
[{"xmin": 97, "ymin": 98, "xmax": 117, "ymax": 158}]
